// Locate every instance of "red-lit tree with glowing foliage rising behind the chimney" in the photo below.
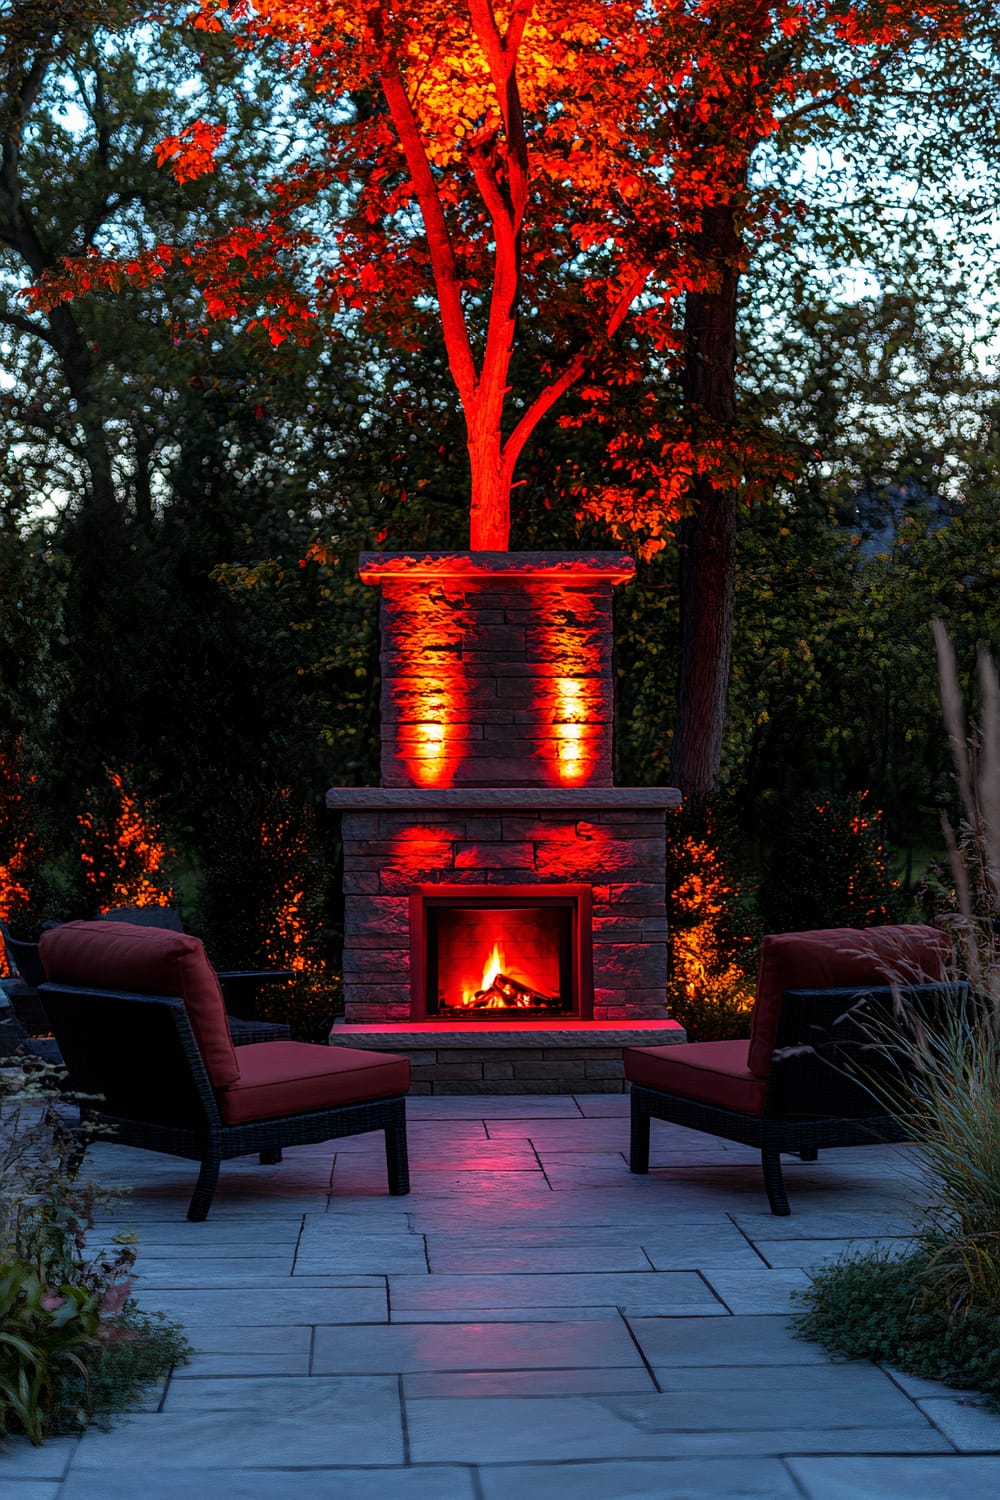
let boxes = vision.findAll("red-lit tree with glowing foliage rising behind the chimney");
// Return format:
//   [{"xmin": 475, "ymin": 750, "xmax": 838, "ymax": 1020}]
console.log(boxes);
[{"xmin": 21, "ymin": 0, "xmax": 958, "ymax": 551}]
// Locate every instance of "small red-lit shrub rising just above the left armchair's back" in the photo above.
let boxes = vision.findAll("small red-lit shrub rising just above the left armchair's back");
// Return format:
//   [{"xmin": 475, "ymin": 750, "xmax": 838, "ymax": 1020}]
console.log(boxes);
[{"xmin": 78, "ymin": 771, "xmax": 174, "ymax": 909}]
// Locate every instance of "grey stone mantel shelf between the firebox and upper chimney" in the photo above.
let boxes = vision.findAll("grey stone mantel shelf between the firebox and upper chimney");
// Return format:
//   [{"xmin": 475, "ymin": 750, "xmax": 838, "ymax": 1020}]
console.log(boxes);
[{"xmin": 327, "ymin": 786, "xmax": 681, "ymax": 813}]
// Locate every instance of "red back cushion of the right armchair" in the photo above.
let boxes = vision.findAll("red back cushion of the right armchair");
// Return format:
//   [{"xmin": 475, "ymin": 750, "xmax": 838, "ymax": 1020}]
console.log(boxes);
[{"xmin": 747, "ymin": 926, "xmax": 951, "ymax": 1079}]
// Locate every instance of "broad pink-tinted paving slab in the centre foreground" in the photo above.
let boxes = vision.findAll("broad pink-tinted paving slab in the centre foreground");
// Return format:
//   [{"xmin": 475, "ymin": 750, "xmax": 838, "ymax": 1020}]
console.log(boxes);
[{"xmin": 312, "ymin": 1320, "xmax": 641, "ymax": 1374}]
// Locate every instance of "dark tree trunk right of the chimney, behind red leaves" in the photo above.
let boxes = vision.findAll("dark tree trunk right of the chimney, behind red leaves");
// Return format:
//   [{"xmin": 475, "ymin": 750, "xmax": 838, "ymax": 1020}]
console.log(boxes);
[{"xmin": 670, "ymin": 204, "xmax": 741, "ymax": 797}]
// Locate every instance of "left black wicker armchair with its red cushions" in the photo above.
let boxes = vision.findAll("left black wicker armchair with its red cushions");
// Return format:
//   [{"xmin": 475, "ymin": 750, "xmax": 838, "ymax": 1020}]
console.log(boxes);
[{"xmin": 40, "ymin": 923, "xmax": 409, "ymax": 1221}]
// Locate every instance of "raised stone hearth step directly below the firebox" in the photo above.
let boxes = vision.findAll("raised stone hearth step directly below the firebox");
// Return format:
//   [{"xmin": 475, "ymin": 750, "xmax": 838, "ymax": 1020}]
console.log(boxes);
[{"xmin": 330, "ymin": 1020, "xmax": 687, "ymax": 1095}]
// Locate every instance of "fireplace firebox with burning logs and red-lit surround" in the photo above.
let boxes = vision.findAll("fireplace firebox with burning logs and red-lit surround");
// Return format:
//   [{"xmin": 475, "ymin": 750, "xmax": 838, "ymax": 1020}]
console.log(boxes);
[{"xmin": 409, "ymin": 884, "xmax": 594, "ymax": 1025}]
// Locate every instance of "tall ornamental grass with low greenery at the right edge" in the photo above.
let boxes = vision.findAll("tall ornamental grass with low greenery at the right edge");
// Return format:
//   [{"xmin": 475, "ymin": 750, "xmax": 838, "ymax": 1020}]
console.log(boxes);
[{"xmin": 796, "ymin": 621, "xmax": 1000, "ymax": 1392}]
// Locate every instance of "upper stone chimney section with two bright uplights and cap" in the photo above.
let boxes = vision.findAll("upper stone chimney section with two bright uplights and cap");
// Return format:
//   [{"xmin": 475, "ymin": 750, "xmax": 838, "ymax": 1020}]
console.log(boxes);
[{"xmin": 361, "ymin": 554, "xmax": 633, "ymax": 786}]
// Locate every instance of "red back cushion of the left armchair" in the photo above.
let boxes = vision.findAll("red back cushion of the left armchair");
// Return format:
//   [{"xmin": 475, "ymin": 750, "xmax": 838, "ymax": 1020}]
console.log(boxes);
[{"xmin": 39, "ymin": 923, "xmax": 240, "ymax": 1089}]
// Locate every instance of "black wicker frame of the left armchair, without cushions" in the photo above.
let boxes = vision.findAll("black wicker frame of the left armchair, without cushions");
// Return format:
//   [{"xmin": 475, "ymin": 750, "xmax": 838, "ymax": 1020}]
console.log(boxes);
[{"xmin": 40, "ymin": 984, "xmax": 409, "ymax": 1223}]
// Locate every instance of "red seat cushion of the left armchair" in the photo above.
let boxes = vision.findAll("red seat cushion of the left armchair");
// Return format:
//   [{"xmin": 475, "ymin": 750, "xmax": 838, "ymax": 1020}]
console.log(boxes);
[{"xmin": 217, "ymin": 1041, "xmax": 409, "ymax": 1125}]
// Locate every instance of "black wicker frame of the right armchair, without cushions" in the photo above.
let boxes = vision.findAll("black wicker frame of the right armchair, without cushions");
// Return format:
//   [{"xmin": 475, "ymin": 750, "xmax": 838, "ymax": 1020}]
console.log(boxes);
[{"xmin": 628, "ymin": 984, "xmax": 969, "ymax": 1217}]
